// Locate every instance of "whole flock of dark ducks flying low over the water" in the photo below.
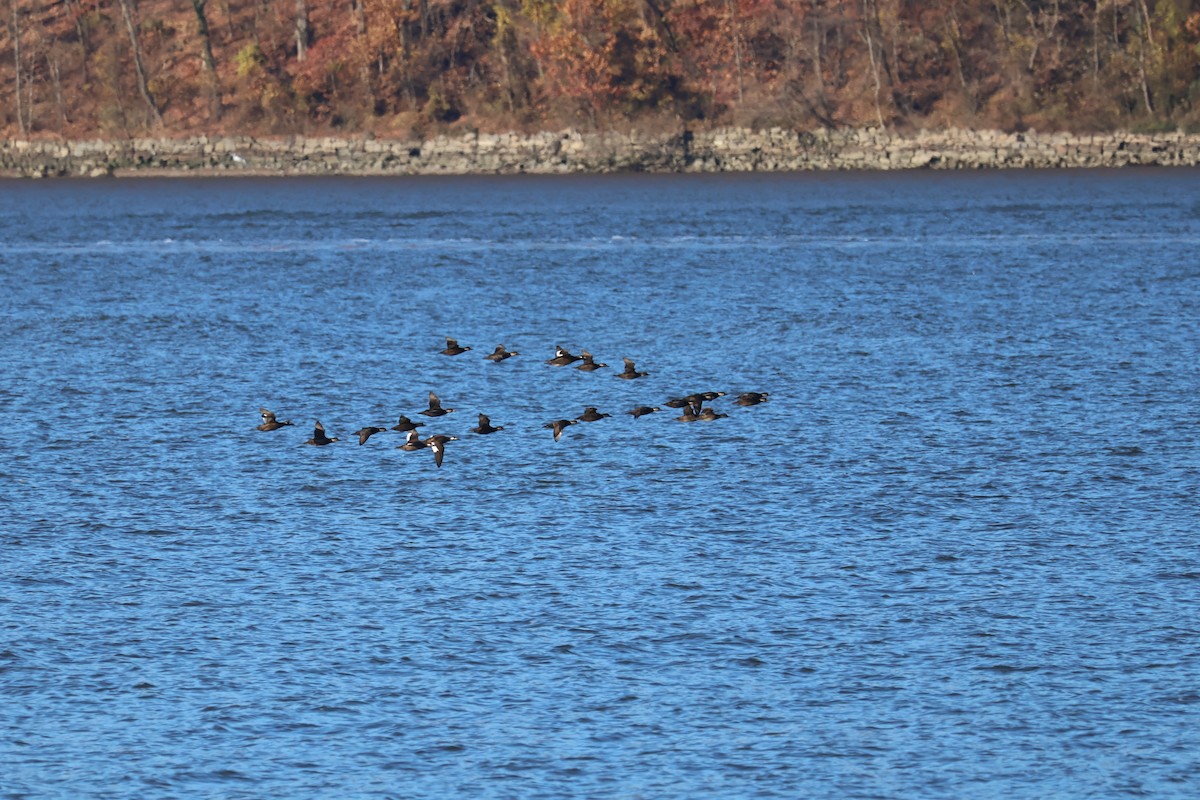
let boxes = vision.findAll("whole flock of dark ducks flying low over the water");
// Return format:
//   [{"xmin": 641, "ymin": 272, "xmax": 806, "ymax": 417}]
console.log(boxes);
[{"xmin": 257, "ymin": 337, "xmax": 769, "ymax": 467}]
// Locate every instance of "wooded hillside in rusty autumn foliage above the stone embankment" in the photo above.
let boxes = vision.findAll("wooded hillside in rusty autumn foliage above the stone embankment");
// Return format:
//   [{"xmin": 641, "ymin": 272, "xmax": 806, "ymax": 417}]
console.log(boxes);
[{"xmin": 0, "ymin": 0, "xmax": 1200, "ymax": 138}]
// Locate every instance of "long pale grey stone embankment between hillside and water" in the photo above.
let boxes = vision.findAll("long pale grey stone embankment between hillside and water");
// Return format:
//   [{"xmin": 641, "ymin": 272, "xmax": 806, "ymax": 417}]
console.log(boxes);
[{"xmin": 0, "ymin": 128, "xmax": 1200, "ymax": 178}]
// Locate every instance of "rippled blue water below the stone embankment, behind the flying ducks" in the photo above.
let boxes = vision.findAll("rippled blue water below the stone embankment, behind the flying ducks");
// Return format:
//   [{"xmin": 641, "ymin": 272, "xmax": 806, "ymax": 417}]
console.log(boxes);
[{"xmin": 0, "ymin": 170, "xmax": 1200, "ymax": 799}]
